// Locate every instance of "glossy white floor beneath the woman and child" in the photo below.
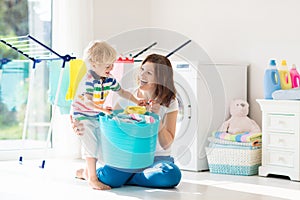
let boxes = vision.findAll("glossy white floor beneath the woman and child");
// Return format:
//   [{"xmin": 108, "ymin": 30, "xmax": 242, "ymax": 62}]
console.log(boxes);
[{"xmin": 0, "ymin": 159, "xmax": 300, "ymax": 200}]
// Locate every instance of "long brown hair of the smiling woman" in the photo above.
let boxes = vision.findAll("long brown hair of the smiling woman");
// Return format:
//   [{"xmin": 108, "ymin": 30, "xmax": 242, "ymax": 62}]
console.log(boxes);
[{"xmin": 142, "ymin": 54, "xmax": 176, "ymax": 107}]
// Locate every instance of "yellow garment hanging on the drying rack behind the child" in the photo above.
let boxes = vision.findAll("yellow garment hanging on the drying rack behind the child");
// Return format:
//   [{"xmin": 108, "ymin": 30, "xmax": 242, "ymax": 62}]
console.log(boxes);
[{"xmin": 66, "ymin": 59, "xmax": 87, "ymax": 100}]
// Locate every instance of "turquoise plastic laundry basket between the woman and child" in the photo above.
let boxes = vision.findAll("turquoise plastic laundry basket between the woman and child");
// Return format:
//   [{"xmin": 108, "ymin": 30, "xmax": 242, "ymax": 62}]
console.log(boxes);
[{"xmin": 99, "ymin": 110, "xmax": 159, "ymax": 169}]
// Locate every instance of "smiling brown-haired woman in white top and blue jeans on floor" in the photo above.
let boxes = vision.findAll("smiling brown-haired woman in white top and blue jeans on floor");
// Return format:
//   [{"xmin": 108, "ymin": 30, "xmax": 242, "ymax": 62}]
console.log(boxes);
[{"xmin": 72, "ymin": 54, "xmax": 181, "ymax": 188}]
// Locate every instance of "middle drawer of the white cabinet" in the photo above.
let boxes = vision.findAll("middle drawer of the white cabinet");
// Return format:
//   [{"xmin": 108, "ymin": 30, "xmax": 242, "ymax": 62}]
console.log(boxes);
[{"xmin": 265, "ymin": 132, "xmax": 297, "ymax": 149}]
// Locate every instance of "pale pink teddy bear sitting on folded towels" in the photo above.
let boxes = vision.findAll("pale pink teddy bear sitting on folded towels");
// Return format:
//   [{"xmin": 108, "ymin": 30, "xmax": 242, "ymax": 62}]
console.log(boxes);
[{"xmin": 219, "ymin": 99, "xmax": 261, "ymax": 134}]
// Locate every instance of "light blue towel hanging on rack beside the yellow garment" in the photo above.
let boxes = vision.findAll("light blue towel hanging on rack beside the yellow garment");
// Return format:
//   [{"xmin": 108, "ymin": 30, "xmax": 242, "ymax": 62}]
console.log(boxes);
[{"xmin": 47, "ymin": 60, "xmax": 71, "ymax": 114}]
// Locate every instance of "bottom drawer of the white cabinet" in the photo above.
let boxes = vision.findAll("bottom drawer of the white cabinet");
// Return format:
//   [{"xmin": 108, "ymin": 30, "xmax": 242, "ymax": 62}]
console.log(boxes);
[{"xmin": 265, "ymin": 150, "xmax": 295, "ymax": 168}]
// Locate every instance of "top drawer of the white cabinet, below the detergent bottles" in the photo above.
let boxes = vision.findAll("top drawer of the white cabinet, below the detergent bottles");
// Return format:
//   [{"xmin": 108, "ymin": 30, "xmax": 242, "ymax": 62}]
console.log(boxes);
[{"xmin": 265, "ymin": 114, "xmax": 297, "ymax": 133}]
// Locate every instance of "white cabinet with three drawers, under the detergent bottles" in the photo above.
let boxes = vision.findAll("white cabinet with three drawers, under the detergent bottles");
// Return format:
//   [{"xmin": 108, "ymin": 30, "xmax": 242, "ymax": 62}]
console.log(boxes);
[{"xmin": 257, "ymin": 99, "xmax": 300, "ymax": 181}]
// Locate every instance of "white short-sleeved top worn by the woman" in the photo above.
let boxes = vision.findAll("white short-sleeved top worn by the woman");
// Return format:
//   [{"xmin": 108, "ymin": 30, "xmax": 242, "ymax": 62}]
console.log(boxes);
[{"xmin": 119, "ymin": 89, "xmax": 178, "ymax": 156}]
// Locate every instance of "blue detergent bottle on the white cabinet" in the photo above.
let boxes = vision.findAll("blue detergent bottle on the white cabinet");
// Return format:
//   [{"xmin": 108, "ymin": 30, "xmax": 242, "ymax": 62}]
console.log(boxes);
[{"xmin": 264, "ymin": 59, "xmax": 281, "ymax": 99}]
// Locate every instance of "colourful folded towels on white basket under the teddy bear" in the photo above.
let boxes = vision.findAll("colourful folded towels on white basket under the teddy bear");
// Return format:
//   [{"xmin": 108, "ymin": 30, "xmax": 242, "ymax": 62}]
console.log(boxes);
[{"xmin": 212, "ymin": 131, "xmax": 262, "ymax": 143}]
